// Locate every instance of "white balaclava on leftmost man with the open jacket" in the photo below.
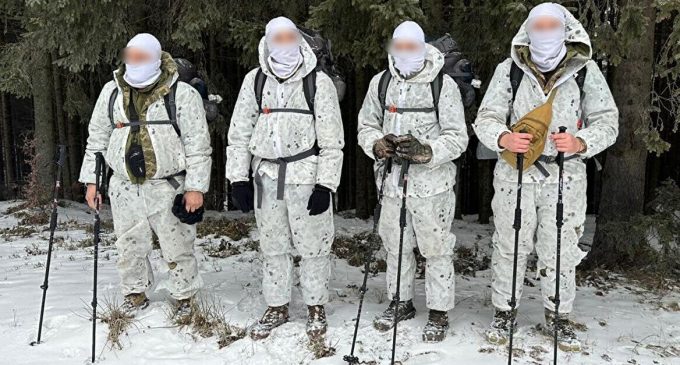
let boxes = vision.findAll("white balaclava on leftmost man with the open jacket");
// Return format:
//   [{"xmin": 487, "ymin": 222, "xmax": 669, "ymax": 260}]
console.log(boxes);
[{"xmin": 123, "ymin": 33, "xmax": 162, "ymax": 89}]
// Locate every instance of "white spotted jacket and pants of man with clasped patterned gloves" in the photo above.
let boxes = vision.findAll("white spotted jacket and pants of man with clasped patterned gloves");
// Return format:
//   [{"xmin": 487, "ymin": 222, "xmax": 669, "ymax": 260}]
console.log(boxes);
[{"xmin": 358, "ymin": 45, "xmax": 468, "ymax": 311}]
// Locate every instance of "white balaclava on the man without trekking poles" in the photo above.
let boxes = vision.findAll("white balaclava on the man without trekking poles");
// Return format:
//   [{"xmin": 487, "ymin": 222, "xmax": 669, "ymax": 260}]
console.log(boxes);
[{"xmin": 264, "ymin": 16, "xmax": 302, "ymax": 79}]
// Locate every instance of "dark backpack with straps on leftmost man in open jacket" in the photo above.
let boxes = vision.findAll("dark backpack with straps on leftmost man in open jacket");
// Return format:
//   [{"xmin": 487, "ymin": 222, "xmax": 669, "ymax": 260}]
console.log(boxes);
[{"xmin": 108, "ymin": 58, "xmax": 221, "ymax": 137}]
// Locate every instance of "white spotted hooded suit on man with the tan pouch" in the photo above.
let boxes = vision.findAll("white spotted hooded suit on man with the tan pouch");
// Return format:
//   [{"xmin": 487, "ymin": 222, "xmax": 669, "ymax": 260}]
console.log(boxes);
[{"xmin": 474, "ymin": 4, "xmax": 619, "ymax": 313}]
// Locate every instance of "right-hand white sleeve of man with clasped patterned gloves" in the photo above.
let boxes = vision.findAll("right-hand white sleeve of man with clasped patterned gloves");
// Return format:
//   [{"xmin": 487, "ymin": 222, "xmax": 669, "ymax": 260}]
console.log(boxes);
[{"xmin": 425, "ymin": 75, "xmax": 468, "ymax": 168}]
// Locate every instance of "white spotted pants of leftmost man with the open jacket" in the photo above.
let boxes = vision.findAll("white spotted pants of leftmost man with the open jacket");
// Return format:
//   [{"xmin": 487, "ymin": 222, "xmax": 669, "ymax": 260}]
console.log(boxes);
[{"xmin": 109, "ymin": 175, "xmax": 203, "ymax": 300}]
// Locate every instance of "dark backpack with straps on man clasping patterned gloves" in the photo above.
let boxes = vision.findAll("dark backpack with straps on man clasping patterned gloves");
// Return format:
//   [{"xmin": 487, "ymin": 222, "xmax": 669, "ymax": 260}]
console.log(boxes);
[{"xmin": 378, "ymin": 33, "xmax": 478, "ymax": 119}]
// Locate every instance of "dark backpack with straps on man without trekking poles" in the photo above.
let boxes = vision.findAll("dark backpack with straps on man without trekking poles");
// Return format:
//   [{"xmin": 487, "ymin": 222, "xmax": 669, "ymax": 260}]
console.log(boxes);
[{"xmin": 254, "ymin": 27, "xmax": 345, "ymax": 118}]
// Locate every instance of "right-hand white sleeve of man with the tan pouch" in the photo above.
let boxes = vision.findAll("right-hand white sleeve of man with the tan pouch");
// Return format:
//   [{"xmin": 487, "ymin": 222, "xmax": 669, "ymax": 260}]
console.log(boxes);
[{"xmin": 576, "ymin": 61, "xmax": 619, "ymax": 158}]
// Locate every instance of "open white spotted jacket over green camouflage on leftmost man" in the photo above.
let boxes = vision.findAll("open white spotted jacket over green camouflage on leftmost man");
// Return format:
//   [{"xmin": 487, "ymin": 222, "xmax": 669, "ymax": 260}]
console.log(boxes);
[{"xmin": 79, "ymin": 55, "xmax": 212, "ymax": 193}]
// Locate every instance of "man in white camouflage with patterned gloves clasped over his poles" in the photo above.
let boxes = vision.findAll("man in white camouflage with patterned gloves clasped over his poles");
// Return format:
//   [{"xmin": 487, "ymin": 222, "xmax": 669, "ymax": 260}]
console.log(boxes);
[{"xmin": 358, "ymin": 21, "xmax": 468, "ymax": 342}]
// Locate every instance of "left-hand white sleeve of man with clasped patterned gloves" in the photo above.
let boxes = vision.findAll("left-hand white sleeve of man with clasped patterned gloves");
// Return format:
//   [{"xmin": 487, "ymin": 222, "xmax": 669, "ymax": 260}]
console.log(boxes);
[{"xmin": 357, "ymin": 71, "xmax": 389, "ymax": 160}]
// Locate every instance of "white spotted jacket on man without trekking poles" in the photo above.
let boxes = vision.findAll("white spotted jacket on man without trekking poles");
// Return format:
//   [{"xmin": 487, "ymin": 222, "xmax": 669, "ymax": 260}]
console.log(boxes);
[{"xmin": 225, "ymin": 37, "xmax": 345, "ymax": 191}]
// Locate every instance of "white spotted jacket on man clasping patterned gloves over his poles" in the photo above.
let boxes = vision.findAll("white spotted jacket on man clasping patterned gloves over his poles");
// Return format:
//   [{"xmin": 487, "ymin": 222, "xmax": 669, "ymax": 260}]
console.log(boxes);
[{"xmin": 357, "ymin": 44, "xmax": 468, "ymax": 197}]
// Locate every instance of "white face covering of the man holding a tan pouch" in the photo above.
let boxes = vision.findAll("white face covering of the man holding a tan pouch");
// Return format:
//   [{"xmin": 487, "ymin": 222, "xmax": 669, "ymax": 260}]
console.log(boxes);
[{"xmin": 529, "ymin": 27, "xmax": 567, "ymax": 73}]
